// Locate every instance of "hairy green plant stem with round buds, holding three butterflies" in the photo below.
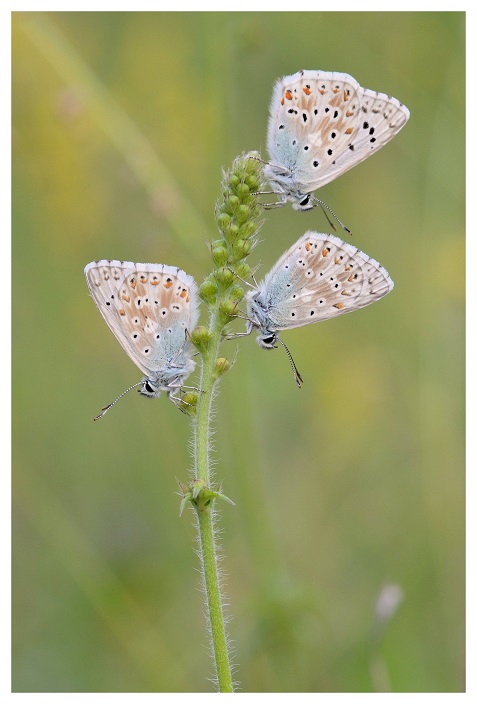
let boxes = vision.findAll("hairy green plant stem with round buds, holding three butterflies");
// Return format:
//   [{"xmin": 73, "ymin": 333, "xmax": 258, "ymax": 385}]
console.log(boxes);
[{"xmin": 187, "ymin": 155, "xmax": 261, "ymax": 692}]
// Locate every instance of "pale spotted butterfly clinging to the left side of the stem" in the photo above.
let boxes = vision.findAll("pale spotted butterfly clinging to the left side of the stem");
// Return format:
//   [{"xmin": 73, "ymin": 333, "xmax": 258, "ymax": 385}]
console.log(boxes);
[{"xmin": 84, "ymin": 259, "xmax": 199, "ymax": 420}]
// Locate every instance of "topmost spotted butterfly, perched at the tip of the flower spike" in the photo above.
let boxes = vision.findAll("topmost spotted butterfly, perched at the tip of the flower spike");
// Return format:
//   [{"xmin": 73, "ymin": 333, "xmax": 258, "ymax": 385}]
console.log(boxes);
[{"xmin": 264, "ymin": 71, "xmax": 410, "ymax": 216}]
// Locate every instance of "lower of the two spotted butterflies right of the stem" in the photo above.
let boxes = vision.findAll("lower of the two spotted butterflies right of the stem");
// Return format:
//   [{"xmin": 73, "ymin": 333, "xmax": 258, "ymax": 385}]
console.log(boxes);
[{"xmin": 235, "ymin": 231, "xmax": 394, "ymax": 386}]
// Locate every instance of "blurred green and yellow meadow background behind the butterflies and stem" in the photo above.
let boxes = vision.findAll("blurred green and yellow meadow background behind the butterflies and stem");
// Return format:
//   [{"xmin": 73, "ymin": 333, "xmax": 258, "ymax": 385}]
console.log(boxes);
[{"xmin": 12, "ymin": 12, "xmax": 465, "ymax": 692}]
